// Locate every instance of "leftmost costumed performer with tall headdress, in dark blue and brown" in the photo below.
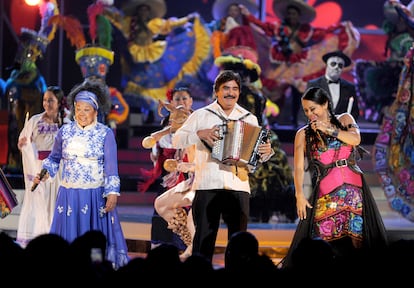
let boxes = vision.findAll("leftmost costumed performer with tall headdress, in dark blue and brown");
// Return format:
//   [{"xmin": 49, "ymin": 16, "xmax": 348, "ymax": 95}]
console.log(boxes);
[{"xmin": 1, "ymin": 0, "xmax": 59, "ymax": 173}]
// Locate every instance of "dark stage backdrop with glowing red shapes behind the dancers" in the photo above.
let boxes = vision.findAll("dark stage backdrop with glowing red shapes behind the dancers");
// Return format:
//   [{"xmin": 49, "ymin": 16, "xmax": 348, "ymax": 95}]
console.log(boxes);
[{"xmin": 2, "ymin": 0, "xmax": 408, "ymax": 95}]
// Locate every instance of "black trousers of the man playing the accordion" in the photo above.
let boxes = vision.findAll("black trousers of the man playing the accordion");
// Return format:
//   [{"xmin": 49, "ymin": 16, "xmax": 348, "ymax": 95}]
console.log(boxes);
[{"xmin": 192, "ymin": 189, "xmax": 250, "ymax": 261}]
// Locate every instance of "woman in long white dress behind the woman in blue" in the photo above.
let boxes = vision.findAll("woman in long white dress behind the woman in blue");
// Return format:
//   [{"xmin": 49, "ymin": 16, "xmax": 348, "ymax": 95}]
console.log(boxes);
[{"xmin": 16, "ymin": 86, "xmax": 69, "ymax": 247}]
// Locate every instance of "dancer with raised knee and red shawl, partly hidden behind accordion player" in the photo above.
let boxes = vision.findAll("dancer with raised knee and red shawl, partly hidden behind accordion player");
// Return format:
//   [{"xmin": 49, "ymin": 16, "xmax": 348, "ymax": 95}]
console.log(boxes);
[{"xmin": 138, "ymin": 87, "xmax": 194, "ymax": 258}]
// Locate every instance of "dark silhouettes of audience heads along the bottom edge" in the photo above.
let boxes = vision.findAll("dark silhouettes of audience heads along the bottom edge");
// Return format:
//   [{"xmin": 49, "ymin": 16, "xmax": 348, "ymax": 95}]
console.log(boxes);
[{"xmin": 0, "ymin": 231, "xmax": 414, "ymax": 287}]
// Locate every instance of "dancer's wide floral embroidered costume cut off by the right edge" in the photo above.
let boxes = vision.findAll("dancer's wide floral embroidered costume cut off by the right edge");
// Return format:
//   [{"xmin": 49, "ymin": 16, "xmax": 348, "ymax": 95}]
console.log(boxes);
[{"xmin": 373, "ymin": 1, "xmax": 414, "ymax": 222}]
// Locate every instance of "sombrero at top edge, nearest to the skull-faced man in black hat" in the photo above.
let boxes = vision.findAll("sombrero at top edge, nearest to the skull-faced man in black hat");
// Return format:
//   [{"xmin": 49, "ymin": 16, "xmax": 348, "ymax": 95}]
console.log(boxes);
[{"xmin": 273, "ymin": 0, "xmax": 316, "ymax": 23}]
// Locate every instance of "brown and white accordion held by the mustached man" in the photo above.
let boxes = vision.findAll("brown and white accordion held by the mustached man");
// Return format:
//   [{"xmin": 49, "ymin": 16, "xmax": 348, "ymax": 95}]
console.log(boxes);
[{"xmin": 211, "ymin": 120, "xmax": 269, "ymax": 168}]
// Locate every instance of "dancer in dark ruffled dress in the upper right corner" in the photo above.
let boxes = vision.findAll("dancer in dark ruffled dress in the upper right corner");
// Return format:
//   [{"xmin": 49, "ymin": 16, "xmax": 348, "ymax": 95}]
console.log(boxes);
[{"xmin": 354, "ymin": 0, "xmax": 414, "ymax": 124}]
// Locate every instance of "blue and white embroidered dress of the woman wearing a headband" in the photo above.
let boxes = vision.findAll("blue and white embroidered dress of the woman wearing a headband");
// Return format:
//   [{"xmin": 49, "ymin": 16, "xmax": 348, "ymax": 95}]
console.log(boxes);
[{"xmin": 43, "ymin": 122, "xmax": 129, "ymax": 269}]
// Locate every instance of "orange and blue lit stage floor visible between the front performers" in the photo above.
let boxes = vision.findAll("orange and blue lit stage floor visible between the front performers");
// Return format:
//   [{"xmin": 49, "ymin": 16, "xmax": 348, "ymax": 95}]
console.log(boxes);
[{"xmin": 118, "ymin": 203, "xmax": 414, "ymax": 267}]
